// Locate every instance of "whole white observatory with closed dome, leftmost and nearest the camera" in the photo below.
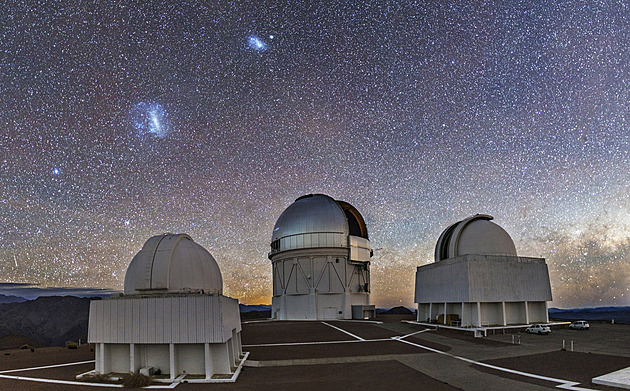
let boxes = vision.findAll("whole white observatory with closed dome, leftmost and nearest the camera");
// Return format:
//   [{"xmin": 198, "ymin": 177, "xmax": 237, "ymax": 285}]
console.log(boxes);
[{"xmin": 88, "ymin": 234, "xmax": 246, "ymax": 382}]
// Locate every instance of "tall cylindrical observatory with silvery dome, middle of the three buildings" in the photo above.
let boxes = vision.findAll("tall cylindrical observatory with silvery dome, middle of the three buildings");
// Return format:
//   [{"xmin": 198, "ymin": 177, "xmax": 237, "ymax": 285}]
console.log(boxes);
[{"xmin": 269, "ymin": 194, "xmax": 374, "ymax": 320}]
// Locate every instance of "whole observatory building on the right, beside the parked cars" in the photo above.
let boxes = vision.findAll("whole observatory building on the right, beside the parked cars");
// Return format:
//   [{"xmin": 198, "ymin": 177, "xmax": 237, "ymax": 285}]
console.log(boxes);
[{"xmin": 414, "ymin": 214, "xmax": 552, "ymax": 327}]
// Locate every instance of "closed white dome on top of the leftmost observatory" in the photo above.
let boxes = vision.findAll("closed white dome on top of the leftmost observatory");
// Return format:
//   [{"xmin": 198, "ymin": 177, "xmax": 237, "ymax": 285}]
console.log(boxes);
[{"xmin": 125, "ymin": 234, "xmax": 223, "ymax": 295}]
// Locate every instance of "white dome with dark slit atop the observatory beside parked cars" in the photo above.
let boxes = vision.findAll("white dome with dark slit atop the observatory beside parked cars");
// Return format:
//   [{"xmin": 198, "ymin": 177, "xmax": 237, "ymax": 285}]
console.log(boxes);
[{"xmin": 435, "ymin": 214, "xmax": 517, "ymax": 262}]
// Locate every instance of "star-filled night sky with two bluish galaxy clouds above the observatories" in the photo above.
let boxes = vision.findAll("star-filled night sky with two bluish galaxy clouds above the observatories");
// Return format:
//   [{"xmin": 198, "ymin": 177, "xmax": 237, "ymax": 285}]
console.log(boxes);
[{"xmin": 0, "ymin": 0, "xmax": 630, "ymax": 307}]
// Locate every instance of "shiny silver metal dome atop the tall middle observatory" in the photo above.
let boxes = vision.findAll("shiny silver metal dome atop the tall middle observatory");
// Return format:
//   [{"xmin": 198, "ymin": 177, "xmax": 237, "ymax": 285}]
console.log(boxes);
[{"xmin": 271, "ymin": 194, "xmax": 368, "ymax": 253}]
